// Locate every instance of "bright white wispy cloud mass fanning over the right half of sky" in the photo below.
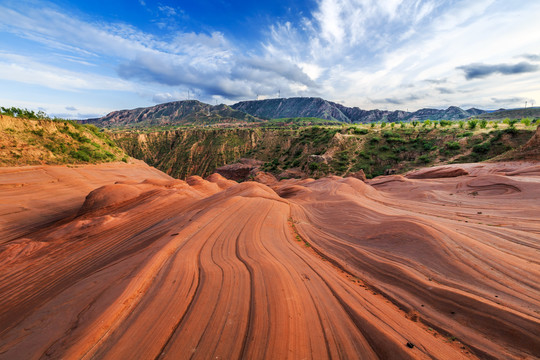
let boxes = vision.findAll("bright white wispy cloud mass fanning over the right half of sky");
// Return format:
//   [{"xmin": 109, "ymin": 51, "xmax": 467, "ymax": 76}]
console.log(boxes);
[{"xmin": 265, "ymin": 0, "xmax": 540, "ymax": 109}]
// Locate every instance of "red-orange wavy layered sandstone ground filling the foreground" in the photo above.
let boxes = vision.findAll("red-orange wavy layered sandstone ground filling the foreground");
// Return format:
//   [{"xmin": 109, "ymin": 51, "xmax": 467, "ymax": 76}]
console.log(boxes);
[{"xmin": 0, "ymin": 163, "xmax": 540, "ymax": 359}]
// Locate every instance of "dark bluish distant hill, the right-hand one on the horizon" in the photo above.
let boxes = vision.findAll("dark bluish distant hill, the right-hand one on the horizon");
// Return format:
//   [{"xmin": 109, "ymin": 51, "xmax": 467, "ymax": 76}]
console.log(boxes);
[{"xmin": 231, "ymin": 97, "xmax": 485, "ymax": 123}]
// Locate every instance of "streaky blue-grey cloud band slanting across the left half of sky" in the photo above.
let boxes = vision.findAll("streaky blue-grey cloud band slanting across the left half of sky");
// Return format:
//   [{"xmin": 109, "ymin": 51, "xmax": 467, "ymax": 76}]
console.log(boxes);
[{"xmin": 0, "ymin": 2, "xmax": 316, "ymax": 99}]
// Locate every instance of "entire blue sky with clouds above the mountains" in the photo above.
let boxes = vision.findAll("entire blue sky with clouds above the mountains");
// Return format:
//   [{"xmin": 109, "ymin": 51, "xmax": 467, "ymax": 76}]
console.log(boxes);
[{"xmin": 0, "ymin": 0, "xmax": 540, "ymax": 118}]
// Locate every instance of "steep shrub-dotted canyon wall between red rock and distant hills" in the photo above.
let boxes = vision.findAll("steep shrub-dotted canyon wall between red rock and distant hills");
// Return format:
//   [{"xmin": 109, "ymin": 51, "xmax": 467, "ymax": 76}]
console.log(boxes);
[{"xmin": 110, "ymin": 120, "xmax": 534, "ymax": 178}]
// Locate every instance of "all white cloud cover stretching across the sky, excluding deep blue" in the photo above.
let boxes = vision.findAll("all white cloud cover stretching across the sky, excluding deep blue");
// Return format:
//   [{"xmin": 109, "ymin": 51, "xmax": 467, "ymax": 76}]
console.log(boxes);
[{"xmin": 0, "ymin": 0, "xmax": 540, "ymax": 109}]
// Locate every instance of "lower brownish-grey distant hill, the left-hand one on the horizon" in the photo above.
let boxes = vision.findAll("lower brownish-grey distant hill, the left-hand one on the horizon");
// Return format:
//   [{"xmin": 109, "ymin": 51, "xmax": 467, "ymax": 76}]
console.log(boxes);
[{"xmin": 83, "ymin": 100, "xmax": 262, "ymax": 127}]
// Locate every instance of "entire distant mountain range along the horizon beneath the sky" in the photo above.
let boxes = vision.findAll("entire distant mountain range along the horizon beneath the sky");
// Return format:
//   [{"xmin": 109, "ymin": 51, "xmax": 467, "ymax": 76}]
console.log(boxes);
[{"xmin": 84, "ymin": 97, "xmax": 486, "ymax": 127}]
